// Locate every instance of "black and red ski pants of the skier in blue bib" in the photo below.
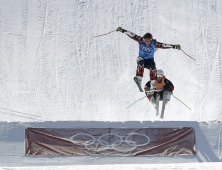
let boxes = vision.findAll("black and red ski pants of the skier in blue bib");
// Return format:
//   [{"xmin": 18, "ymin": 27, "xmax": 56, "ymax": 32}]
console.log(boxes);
[{"xmin": 136, "ymin": 56, "xmax": 156, "ymax": 80}]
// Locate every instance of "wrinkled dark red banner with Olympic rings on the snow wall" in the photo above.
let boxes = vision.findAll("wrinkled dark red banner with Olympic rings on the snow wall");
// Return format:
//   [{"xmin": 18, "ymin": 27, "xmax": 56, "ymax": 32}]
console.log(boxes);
[{"xmin": 25, "ymin": 127, "xmax": 196, "ymax": 156}]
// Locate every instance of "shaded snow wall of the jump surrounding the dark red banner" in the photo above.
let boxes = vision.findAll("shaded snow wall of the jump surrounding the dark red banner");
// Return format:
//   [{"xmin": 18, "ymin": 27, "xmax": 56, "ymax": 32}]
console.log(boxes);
[{"xmin": 0, "ymin": 121, "xmax": 222, "ymax": 168}]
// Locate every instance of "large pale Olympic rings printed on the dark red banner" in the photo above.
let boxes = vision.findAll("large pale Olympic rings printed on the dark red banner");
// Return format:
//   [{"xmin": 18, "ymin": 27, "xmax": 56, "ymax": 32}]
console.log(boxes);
[{"xmin": 71, "ymin": 133, "xmax": 150, "ymax": 152}]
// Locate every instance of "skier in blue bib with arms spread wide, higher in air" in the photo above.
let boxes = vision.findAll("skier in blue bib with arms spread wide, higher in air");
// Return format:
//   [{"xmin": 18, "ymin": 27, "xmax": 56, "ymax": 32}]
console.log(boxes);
[{"xmin": 116, "ymin": 27, "xmax": 181, "ymax": 91}]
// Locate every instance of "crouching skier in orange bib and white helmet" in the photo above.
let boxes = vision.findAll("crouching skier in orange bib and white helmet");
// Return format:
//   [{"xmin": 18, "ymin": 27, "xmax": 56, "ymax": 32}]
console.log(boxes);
[{"xmin": 144, "ymin": 70, "xmax": 174, "ymax": 108}]
